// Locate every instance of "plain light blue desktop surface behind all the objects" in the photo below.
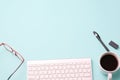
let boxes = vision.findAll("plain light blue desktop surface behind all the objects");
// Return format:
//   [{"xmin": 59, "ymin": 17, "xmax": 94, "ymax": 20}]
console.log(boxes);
[{"xmin": 0, "ymin": 0, "xmax": 120, "ymax": 80}]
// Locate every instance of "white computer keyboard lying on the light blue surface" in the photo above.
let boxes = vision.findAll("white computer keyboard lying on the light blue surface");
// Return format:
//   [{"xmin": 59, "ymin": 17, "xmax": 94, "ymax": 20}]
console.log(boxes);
[{"xmin": 27, "ymin": 58, "xmax": 92, "ymax": 80}]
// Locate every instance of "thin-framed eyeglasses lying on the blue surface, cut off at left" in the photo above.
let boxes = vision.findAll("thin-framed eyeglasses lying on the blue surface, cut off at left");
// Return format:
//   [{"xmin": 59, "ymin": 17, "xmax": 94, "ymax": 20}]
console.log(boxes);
[{"xmin": 0, "ymin": 43, "xmax": 24, "ymax": 80}]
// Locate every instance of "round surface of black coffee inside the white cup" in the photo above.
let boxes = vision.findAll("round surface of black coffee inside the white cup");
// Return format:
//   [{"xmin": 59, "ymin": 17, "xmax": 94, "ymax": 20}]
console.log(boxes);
[{"xmin": 100, "ymin": 54, "xmax": 118, "ymax": 71}]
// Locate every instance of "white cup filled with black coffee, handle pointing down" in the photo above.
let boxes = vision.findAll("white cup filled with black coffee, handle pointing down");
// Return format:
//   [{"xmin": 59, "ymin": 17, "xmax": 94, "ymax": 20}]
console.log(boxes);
[{"xmin": 99, "ymin": 52, "xmax": 120, "ymax": 80}]
